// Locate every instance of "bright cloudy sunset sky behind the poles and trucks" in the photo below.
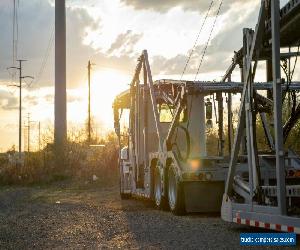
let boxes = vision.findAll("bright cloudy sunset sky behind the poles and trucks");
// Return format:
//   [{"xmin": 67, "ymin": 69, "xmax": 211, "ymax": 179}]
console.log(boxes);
[{"xmin": 0, "ymin": 0, "xmax": 296, "ymax": 151}]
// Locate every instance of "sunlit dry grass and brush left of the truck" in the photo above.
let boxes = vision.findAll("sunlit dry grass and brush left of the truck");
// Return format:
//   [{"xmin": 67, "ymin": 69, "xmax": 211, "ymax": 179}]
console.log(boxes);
[{"xmin": 0, "ymin": 133, "xmax": 118, "ymax": 185}]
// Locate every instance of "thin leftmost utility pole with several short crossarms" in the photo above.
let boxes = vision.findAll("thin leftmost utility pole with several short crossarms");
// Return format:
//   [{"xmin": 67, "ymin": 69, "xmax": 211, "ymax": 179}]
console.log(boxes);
[{"xmin": 7, "ymin": 59, "xmax": 34, "ymax": 162}]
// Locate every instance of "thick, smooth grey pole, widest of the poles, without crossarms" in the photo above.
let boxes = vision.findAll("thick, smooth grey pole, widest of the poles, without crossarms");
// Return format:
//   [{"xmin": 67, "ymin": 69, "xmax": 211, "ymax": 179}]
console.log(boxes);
[{"xmin": 54, "ymin": 0, "xmax": 67, "ymax": 150}]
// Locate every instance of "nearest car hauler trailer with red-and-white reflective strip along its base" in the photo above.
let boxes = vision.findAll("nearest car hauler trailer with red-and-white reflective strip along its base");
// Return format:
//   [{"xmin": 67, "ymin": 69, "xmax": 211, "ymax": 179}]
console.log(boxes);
[{"xmin": 221, "ymin": 0, "xmax": 300, "ymax": 234}]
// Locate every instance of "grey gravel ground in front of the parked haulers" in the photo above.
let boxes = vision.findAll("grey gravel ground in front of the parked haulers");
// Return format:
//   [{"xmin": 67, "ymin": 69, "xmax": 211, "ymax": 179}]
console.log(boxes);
[{"xmin": 0, "ymin": 184, "xmax": 299, "ymax": 249}]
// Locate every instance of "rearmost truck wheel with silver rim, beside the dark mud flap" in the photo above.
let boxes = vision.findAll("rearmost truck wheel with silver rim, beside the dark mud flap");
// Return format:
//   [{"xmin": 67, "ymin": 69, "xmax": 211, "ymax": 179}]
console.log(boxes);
[{"xmin": 168, "ymin": 165, "xmax": 186, "ymax": 215}]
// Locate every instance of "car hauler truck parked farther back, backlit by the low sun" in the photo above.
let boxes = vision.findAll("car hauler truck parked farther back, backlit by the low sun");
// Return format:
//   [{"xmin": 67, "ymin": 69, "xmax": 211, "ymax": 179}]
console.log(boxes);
[{"xmin": 113, "ymin": 51, "xmax": 300, "ymax": 214}]
